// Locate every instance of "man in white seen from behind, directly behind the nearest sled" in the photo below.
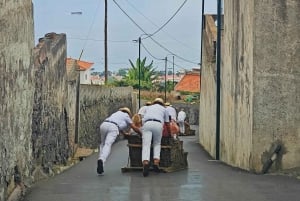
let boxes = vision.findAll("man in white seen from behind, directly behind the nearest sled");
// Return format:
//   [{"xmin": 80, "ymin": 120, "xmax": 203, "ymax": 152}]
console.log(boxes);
[{"xmin": 142, "ymin": 98, "xmax": 171, "ymax": 177}]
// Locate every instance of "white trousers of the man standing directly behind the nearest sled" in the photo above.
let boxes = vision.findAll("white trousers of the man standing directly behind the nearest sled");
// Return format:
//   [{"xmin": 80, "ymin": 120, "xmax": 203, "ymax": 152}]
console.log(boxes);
[{"xmin": 142, "ymin": 121, "xmax": 163, "ymax": 161}]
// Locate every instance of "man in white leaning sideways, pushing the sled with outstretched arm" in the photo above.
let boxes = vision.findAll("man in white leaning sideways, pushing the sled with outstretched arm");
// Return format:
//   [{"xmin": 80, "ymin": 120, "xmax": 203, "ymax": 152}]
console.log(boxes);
[{"xmin": 97, "ymin": 107, "xmax": 142, "ymax": 174}]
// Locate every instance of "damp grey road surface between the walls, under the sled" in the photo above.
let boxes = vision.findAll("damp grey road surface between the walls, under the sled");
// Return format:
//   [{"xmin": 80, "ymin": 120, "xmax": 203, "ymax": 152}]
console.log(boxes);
[{"xmin": 25, "ymin": 137, "xmax": 300, "ymax": 201}]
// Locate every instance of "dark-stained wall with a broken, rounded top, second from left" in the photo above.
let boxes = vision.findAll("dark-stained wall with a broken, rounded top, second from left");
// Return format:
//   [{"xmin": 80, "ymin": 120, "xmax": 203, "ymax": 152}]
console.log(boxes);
[{"xmin": 32, "ymin": 33, "xmax": 70, "ymax": 173}]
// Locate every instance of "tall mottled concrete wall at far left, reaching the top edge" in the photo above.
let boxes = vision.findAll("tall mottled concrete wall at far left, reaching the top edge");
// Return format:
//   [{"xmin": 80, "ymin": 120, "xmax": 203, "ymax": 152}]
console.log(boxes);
[{"xmin": 0, "ymin": 0, "xmax": 34, "ymax": 201}]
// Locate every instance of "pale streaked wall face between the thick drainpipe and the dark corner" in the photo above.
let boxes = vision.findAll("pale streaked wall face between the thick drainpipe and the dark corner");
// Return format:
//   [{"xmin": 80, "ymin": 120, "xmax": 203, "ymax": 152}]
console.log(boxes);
[{"xmin": 220, "ymin": 1, "xmax": 254, "ymax": 169}]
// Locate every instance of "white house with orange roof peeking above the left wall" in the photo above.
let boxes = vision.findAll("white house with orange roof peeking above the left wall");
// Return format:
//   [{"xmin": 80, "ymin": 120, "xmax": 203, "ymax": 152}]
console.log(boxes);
[{"xmin": 67, "ymin": 58, "xmax": 94, "ymax": 84}]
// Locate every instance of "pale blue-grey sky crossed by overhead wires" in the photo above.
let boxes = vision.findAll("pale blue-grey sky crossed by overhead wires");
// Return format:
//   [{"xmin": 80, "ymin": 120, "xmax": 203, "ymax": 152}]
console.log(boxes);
[{"xmin": 32, "ymin": 0, "xmax": 217, "ymax": 72}]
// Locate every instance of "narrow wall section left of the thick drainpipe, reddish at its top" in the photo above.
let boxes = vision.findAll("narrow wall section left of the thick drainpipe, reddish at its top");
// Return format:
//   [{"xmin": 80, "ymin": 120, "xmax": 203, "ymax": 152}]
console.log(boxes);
[{"xmin": 199, "ymin": 15, "xmax": 217, "ymax": 156}]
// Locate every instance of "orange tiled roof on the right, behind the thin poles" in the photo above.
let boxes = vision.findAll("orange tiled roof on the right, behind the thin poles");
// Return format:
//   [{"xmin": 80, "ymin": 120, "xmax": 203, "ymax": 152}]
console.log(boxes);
[{"xmin": 175, "ymin": 72, "xmax": 200, "ymax": 93}]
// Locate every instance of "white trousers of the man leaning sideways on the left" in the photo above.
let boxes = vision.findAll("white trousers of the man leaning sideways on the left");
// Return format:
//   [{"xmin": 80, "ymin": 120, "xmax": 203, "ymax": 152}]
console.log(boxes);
[{"xmin": 98, "ymin": 122, "xmax": 119, "ymax": 163}]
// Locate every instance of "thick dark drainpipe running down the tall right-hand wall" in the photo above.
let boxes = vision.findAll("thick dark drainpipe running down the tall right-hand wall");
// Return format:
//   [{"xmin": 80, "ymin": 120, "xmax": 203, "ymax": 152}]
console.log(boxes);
[{"xmin": 216, "ymin": 0, "xmax": 222, "ymax": 160}]
